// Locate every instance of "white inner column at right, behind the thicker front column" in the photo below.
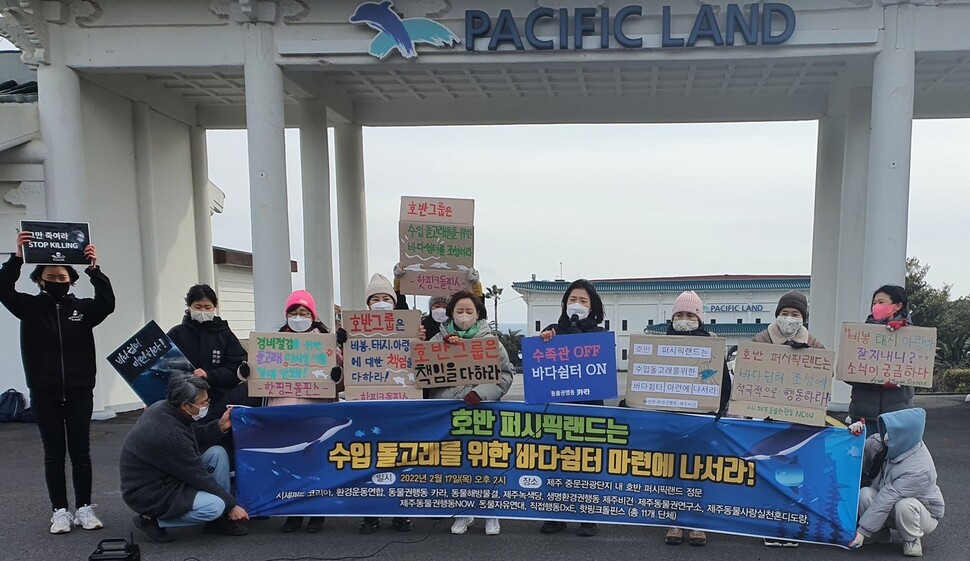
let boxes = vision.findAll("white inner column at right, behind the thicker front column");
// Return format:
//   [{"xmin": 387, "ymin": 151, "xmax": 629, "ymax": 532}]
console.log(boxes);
[{"xmin": 809, "ymin": 113, "xmax": 845, "ymax": 348}]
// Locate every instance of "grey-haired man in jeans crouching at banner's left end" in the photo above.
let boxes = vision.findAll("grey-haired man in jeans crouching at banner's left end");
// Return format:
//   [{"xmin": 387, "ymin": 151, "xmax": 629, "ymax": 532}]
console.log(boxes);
[{"xmin": 119, "ymin": 375, "xmax": 249, "ymax": 543}]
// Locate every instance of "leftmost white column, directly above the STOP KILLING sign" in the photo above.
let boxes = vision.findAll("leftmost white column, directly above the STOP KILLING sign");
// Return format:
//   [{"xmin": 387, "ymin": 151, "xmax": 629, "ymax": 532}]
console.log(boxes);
[{"xmin": 37, "ymin": 24, "xmax": 87, "ymax": 221}]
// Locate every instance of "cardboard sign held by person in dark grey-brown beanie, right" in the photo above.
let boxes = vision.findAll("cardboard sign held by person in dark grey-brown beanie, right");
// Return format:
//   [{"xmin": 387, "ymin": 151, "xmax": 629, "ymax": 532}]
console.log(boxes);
[{"xmin": 728, "ymin": 341, "xmax": 835, "ymax": 427}]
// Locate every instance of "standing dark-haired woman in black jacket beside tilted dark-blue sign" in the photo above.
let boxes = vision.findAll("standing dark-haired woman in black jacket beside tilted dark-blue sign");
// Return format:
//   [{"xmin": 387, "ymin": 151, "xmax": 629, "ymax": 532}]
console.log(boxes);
[{"xmin": 168, "ymin": 284, "xmax": 253, "ymax": 423}]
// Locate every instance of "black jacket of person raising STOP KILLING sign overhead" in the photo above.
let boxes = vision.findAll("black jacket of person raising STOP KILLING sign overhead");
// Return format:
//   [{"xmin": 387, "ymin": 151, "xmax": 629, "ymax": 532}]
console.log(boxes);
[{"xmin": 0, "ymin": 255, "xmax": 115, "ymax": 401}]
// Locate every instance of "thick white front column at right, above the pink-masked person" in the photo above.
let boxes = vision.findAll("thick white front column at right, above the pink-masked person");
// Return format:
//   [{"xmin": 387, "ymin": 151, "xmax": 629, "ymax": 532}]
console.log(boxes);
[{"xmin": 862, "ymin": 5, "xmax": 916, "ymax": 290}]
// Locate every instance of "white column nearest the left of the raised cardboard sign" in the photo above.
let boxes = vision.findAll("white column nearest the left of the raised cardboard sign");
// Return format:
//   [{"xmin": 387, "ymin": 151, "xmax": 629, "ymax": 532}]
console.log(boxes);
[{"xmin": 334, "ymin": 123, "xmax": 369, "ymax": 309}]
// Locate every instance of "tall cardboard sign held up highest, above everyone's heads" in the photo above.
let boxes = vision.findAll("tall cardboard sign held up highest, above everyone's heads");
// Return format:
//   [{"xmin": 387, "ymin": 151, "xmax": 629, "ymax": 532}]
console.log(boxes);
[{"xmin": 398, "ymin": 197, "xmax": 475, "ymax": 296}]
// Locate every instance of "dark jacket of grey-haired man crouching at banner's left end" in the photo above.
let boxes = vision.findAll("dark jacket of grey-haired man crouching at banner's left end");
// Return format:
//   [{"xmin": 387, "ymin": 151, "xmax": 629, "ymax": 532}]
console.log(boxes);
[{"xmin": 119, "ymin": 400, "xmax": 236, "ymax": 520}]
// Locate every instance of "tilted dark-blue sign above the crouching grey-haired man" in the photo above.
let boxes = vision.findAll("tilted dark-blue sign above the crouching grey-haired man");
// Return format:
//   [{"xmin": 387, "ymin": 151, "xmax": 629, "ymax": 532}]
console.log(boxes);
[{"xmin": 108, "ymin": 321, "xmax": 195, "ymax": 405}]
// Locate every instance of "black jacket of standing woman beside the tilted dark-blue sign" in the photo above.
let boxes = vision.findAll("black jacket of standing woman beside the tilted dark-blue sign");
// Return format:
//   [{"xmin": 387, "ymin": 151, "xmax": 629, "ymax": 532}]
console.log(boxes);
[{"xmin": 168, "ymin": 312, "xmax": 246, "ymax": 403}]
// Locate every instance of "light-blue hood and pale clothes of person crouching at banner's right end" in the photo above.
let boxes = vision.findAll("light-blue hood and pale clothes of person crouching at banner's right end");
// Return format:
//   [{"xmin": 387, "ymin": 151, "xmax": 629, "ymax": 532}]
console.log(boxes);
[{"xmin": 859, "ymin": 408, "xmax": 946, "ymax": 536}]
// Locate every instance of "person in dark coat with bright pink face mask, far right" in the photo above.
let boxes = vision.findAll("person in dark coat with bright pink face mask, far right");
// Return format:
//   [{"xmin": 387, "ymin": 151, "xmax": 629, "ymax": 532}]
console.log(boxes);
[{"xmin": 849, "ymin": 285, "xmax": 914, "ymax": 434}]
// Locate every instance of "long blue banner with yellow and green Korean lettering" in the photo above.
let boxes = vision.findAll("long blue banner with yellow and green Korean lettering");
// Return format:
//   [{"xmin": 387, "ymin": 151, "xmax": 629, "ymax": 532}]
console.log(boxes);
[{"xmin": 232, "ymin": 400, "xmax": 863, "ymax": 547}]
